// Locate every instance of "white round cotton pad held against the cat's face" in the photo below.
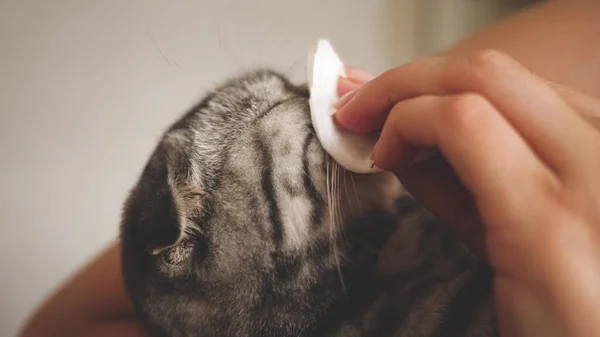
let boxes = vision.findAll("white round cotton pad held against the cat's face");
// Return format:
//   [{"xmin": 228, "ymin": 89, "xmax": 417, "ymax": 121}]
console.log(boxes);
[{"xmin": 307, "ymin": 40, "xmax": 381, "ymax": 173}]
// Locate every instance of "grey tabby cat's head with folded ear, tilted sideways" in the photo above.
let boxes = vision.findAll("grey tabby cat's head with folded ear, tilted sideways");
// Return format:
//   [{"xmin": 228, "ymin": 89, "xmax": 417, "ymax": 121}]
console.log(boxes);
[{"xmin": 121, "ymin": 71, "xmax": 400, "ymax": 336}]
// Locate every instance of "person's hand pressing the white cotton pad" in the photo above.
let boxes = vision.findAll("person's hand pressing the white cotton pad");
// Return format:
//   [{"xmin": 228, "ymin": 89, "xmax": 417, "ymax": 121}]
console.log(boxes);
[{"xmin": 335, "ymin": 52, "xmax": 600, "ymax": 336}]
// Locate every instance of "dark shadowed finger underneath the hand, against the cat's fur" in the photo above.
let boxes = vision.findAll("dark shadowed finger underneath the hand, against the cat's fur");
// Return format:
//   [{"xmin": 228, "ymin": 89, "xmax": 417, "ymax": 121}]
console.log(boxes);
[{"xmin": 396, "ymin": 156, "xmax": 485, "ymax": 255}]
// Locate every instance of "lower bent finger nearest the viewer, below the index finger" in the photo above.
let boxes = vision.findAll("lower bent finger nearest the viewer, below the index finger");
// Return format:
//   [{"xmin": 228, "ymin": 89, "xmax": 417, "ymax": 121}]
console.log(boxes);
[{"xmin": 373, "ymin": 93, "xmax": 559, "ymax": 231}]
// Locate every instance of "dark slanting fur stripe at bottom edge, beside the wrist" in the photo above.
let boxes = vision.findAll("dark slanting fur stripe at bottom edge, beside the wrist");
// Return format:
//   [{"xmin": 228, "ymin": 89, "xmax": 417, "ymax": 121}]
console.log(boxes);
[{"xmin": 431, "ymin": 263, "xmax": 493, "ymax": 337}]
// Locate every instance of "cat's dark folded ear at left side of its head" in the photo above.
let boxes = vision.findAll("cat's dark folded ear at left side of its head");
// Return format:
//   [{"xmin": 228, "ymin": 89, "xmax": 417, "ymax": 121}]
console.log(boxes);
[{"xmin": 122, "ymin": 131, "xmax": 201, "ymax": 255}]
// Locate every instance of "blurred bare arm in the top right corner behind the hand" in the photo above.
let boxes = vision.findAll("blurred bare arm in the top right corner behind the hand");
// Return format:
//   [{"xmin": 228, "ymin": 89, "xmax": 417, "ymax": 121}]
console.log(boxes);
[{"xmin": 442, "ymin": 0, "xmax": 600, "ymax": 97}]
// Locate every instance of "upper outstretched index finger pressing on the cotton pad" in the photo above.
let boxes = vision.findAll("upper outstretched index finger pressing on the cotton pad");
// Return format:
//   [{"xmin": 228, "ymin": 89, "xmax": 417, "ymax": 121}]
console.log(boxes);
[{"xmin": 336, "ymin": 52, "xmax": 598, "ymax": 173}]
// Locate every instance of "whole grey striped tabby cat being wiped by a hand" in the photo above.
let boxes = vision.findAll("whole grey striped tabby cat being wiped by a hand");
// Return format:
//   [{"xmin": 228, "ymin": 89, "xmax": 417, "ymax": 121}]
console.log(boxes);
[{"xmin": 121, "ymin": 71, "xmax": 497, "ymax": 337}]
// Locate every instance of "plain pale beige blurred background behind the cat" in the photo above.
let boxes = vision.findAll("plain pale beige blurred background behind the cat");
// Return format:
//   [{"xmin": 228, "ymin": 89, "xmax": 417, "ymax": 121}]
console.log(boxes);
[{"xmin": 0, "ymin": 0, "xmax": 528, "ymax": 336}]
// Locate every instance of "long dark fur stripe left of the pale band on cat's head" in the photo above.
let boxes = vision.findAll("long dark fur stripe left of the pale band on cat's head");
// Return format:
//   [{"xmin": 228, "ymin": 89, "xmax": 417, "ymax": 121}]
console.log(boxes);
[{"xmin": 254, "ymin": 134, "xmax": 283, "ymax": 251}]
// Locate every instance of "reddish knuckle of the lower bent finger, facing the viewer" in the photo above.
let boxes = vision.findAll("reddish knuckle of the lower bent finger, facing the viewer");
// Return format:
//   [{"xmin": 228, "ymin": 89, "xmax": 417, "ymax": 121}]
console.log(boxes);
[{"xmin": 442, "ymin": 93, "xmax": 488, "ymax": 131}]
